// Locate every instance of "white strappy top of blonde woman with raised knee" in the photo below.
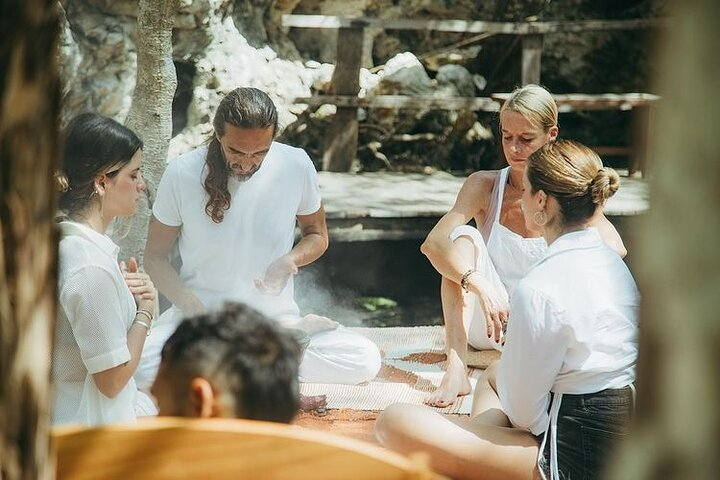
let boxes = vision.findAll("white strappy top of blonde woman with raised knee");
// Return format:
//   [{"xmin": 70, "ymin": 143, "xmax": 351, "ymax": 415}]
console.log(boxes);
[{"xmin": 482, "ymin": 167, "xmax": 547, "ymax": 296}]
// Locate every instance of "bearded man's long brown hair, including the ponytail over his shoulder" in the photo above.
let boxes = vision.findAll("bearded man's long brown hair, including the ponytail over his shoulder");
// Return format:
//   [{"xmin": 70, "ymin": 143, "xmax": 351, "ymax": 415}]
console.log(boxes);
[{"xmin": 203, "ymin": 87, "xmax": 278, "ymax": 223}]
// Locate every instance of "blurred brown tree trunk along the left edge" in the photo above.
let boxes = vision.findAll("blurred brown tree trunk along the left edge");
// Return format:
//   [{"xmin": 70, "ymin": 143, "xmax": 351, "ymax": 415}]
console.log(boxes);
[{"xmin": 0, "ymin": 0, "xmax": 60, "ymax": 480}]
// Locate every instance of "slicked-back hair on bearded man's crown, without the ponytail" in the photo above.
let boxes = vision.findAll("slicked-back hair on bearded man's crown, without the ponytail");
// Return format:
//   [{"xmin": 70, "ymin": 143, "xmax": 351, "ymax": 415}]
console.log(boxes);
[{"xmin": 213, "ymin": 87, "xmax": 278, "ymax": 136}]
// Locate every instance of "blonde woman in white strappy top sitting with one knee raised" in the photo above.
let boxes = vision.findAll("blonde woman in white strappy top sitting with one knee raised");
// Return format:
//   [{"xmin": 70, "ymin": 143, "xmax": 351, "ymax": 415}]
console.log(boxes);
[{"xmin": 421, "ymin": 85, "xmax": 626, "ymax": 407}]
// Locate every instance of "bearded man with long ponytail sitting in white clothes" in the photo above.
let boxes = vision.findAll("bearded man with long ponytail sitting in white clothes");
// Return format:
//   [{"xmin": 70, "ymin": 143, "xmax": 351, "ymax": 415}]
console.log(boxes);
[{"xmin": 136, "ymin": 87, "xmax": 380, "ymax": 392}]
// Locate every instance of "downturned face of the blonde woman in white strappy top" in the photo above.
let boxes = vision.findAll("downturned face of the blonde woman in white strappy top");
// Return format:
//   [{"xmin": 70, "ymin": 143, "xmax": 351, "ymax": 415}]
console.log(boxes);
[{"xmin": 500, "ymin": 110, "xmax": 557, "ymax": 168}]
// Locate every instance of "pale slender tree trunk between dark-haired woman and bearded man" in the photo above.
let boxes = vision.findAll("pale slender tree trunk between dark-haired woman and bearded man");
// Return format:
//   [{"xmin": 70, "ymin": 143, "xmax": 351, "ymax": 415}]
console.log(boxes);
[{"xmin": 113, "ymin": 0, "xmax": 177, "ymax": 263}]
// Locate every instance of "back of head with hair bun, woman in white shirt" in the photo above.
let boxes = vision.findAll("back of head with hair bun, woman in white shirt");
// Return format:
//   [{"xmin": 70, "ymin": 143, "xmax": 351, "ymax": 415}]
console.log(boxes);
[{"xmin": 527, "ymin": 140, "xmax": 620, "ymax": 224}]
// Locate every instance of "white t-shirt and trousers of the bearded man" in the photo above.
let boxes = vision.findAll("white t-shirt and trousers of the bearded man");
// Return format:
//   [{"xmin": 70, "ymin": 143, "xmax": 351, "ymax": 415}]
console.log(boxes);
[{"xmin": 141, "ymin": 142, "xmax": 381, "ymax": 386}]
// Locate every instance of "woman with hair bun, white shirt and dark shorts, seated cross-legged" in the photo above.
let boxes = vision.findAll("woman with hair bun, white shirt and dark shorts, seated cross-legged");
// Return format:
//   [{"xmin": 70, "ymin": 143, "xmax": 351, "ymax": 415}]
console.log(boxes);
[{"xmin": 376, "ymin": 140, "xmax": 639, "ymax": 479}]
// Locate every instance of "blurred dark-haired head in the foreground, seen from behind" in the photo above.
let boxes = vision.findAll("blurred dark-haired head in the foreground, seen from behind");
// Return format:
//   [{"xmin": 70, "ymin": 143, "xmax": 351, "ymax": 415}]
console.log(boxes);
[{"xmin": 161, "ymin": 303, "xmax": 300, "ymax": 423}]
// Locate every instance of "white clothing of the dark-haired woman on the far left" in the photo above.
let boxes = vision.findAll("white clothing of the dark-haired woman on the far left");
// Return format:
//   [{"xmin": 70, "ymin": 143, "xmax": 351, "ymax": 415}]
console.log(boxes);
[{"xmin": 52, "ymin": 221, "xmax": 157, "ymax": 425}]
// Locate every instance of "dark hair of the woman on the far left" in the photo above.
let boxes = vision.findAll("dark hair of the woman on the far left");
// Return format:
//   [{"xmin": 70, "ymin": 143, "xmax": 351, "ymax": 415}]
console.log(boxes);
[{"xmin": 56, "ymin": 113, "xmax": 143, "ymax": 213}]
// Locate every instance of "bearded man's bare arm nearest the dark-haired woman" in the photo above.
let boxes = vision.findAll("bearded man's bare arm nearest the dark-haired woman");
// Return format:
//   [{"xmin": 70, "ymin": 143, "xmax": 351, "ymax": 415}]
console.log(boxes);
[{"xmin": 145, "ymin": 217, "xmax": 205, "ymax": 315}]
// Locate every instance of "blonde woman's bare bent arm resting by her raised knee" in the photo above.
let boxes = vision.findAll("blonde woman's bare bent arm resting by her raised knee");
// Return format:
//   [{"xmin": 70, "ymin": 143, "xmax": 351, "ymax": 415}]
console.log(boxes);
[{"xmin": 420, "ymin": 172, "xmax": 493, "ymax": 283}]
